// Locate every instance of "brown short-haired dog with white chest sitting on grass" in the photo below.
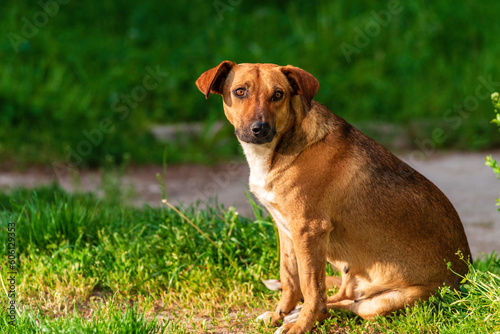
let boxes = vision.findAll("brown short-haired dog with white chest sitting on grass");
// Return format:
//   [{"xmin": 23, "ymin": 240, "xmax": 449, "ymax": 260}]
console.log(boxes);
[{"xmin": 196, "ymin": 61, "xmax": 470, "ymax": 333}]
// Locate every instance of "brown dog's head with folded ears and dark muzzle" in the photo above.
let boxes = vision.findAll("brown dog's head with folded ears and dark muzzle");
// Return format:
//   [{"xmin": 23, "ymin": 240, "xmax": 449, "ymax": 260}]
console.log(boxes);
[{"xmin": 196, "ymin": 60, "xmax": 319, "ymax": 144}]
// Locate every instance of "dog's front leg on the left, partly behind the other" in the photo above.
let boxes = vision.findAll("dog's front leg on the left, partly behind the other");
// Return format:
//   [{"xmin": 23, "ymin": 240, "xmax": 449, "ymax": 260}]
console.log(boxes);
[{"xmin": 271, "ymin": 230, "xmax": 302, "ymax": 326}]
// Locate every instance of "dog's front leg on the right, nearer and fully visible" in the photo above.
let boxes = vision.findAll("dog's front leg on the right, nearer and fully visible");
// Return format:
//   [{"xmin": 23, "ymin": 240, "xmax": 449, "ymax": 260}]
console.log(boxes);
[{"xmin": 281, "ymin": 220, "xmax": 332, "ymax": 334}]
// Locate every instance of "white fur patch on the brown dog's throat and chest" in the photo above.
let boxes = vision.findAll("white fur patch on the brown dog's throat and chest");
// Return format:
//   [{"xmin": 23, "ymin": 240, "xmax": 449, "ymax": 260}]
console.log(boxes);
[{"xmin": 240, "ymin": 141, "xmax": 292, "ymax": 238}]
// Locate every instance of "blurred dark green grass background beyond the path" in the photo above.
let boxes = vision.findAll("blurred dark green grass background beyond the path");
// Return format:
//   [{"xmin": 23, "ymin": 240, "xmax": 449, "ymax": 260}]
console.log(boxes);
[{"xmin": 0, "ymin": 0, "xmax": 500, "ymax": 168}]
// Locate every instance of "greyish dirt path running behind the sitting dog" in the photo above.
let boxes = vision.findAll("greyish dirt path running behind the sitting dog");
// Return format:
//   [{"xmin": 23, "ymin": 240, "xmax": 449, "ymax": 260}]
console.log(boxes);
[{"xmin": 0, "ymin": 151, "xmax": 500, "ymax": 256}]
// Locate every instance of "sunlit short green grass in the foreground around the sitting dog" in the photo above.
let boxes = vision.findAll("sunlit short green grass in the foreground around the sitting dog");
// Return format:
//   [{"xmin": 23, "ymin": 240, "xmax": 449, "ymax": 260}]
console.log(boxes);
[{"xmin": 0, "ymin": 186, "xmax": 500, "ymax": 333}]
